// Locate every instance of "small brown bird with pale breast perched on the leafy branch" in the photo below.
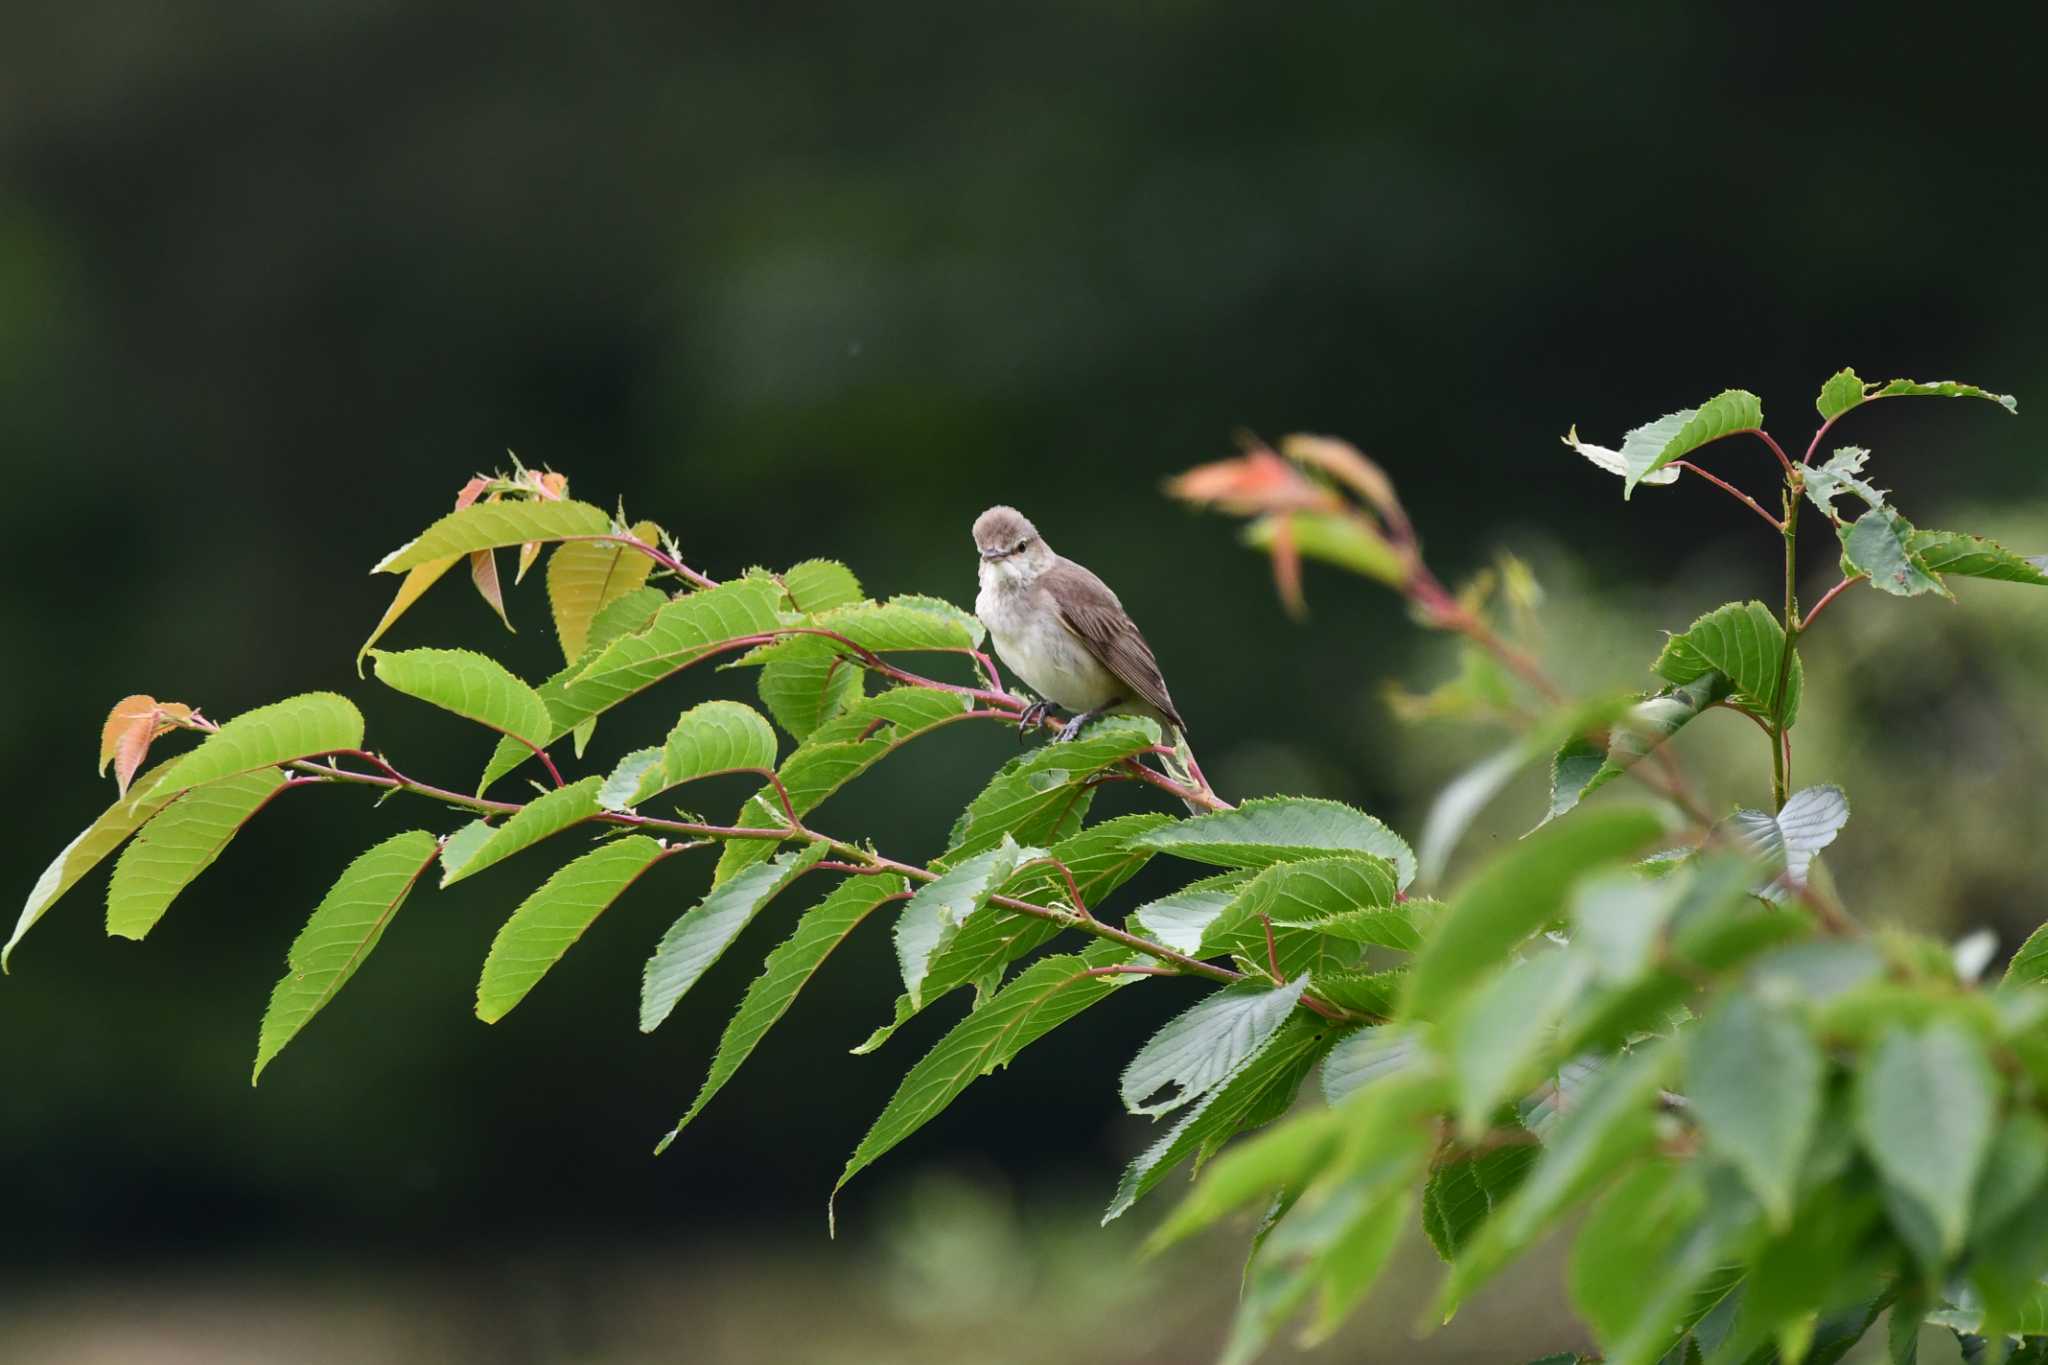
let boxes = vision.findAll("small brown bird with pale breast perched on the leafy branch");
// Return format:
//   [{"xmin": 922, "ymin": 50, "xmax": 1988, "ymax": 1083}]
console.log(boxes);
[{"xmin": 975, "ymin": 505, "xmax": 1188, "ymax": 745}]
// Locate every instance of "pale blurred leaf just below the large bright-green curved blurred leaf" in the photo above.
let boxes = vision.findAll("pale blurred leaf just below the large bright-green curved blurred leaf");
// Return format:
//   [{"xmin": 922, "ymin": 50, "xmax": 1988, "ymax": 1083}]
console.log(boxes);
[{"xmin": 1438, "ymin": 948, "xmax": 1593, "ymax": 1142}]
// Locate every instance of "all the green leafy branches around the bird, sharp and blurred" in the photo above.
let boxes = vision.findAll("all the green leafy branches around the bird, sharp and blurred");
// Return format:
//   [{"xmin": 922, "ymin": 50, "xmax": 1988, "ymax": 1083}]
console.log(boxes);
[{"xmin": 6, "ymin": 370, "xmax": 2048, "ymax": 1365}]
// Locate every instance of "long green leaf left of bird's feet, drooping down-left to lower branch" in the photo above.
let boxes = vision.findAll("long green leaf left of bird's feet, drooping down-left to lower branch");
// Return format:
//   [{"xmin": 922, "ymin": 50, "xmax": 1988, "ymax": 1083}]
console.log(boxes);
[{"xmin": 713, "ymin": 688, "xmax": 973, "ymax": 886}]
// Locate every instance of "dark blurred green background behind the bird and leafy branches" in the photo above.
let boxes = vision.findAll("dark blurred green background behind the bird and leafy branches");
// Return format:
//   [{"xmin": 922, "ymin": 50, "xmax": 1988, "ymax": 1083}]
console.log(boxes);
[{"xmin": 0, "ymin": 0, "xmax": 2048, "ymax": 1363}]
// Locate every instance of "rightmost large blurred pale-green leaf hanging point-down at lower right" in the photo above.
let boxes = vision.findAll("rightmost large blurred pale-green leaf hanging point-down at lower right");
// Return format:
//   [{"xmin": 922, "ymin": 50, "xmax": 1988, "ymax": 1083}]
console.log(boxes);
[{"xmin": 1855, "ymin": 1021, "xmax": 1999, "ymax": 1257}]
